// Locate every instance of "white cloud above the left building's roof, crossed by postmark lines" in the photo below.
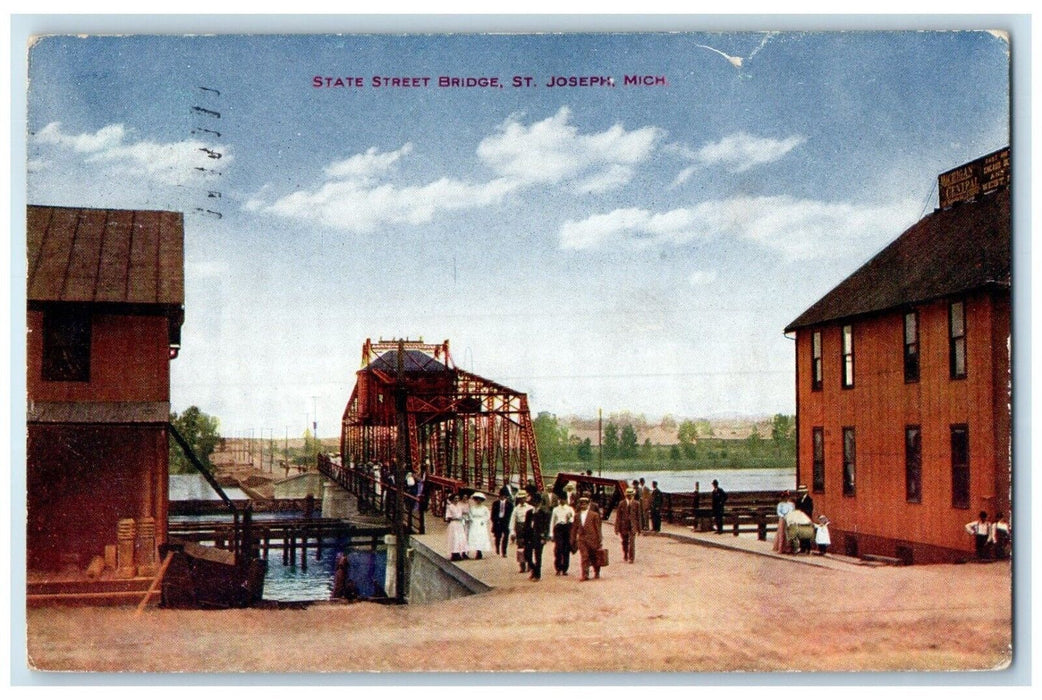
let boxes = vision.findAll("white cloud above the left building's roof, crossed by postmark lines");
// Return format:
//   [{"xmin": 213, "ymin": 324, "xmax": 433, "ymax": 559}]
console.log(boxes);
[{"xmin": 31, "ymin": 122, "xmax": 233, "ymax": 186}]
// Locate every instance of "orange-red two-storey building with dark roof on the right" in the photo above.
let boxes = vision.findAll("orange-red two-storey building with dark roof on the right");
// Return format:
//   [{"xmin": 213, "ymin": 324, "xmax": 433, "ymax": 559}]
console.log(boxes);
[{"xmin": 786, "ymin": 149, "xmax": 1011, "ymax": 563}]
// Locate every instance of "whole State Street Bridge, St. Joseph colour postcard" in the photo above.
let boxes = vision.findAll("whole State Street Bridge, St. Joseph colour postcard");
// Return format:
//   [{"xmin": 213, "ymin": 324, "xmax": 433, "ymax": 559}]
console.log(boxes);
[{"xmin": 15, "ymin": 26, "xmax": 1026, "ymax": 682}]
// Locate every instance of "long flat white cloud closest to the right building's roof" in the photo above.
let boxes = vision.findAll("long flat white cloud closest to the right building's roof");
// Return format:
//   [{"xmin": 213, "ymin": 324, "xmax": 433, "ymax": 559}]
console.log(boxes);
[{"xmin": 560, "ymin": 196, "xmax": 918, "ymax": 262}]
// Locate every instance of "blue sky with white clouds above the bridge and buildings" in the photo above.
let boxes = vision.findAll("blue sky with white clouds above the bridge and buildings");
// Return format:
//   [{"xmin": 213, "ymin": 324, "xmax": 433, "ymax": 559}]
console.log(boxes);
[{"xmin": 27, "ymin": 31, "xmax": 1010, "ymax": 438}]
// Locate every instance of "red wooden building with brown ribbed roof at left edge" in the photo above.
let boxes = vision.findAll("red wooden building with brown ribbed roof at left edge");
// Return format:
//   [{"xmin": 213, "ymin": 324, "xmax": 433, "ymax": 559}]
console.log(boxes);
[{"xmin": 26, "ymin": 206, "xmax": 184, "ymax": 572}]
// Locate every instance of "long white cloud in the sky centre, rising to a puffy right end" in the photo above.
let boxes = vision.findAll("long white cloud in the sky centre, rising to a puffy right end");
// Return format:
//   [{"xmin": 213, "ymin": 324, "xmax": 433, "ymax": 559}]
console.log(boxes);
[{"xmin": 256, "ymin": 107, "xmax": 662, "ymax": 232}]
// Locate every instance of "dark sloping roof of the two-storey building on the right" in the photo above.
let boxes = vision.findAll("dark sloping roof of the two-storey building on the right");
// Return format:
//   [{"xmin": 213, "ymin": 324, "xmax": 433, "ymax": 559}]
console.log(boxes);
[{"xmin": 786, "ymin": 189, "xmax": 1012, "ymax": 332}]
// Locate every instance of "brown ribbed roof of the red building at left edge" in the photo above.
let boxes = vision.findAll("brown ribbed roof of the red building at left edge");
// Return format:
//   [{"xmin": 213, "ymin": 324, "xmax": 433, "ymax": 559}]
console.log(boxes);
[{"xmin": 26, "ymin": 206, "xmax": 184, "ymax": 306}]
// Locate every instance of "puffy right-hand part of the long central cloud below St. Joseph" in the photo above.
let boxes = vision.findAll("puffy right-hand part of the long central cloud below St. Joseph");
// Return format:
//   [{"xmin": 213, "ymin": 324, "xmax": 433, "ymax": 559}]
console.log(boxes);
[{"xmin": 477, "ymin": 107, "xmax": 663, "ymax": 193}]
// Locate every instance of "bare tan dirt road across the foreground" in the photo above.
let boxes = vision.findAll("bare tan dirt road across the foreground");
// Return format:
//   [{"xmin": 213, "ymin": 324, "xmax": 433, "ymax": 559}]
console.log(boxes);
[{"xmin": 27, "ymin": 526, "xmax": 1012, "ymax": 672}]
